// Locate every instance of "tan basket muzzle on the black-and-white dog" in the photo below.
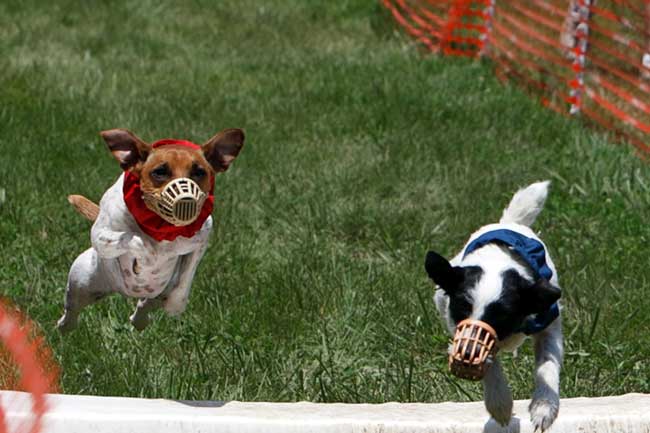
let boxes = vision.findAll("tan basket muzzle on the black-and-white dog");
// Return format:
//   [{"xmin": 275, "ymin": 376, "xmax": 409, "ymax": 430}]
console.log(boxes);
[{"xmin": 449, "ymin": 319, "xmax": 497, "ymax": 380}]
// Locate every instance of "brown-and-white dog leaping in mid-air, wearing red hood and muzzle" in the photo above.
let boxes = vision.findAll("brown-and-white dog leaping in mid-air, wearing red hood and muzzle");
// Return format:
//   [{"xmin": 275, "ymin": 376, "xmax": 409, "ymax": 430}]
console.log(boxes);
[{"xmin": 57, "ymin": 129, "xmax": 244, "ymax": 332}]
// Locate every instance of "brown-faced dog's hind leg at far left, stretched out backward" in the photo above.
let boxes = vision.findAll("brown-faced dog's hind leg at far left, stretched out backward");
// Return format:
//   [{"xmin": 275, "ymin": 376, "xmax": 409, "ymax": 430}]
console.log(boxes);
[{"xmin": 57, "ymin": 248, "xmax": 112, "ymax": 333}]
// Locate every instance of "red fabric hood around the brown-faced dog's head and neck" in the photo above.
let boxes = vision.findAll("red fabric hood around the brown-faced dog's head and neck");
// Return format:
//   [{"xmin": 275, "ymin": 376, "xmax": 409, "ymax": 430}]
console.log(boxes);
[{"xmin": 122, "ymin": 139, "xmax": 214, "ymax": 242}]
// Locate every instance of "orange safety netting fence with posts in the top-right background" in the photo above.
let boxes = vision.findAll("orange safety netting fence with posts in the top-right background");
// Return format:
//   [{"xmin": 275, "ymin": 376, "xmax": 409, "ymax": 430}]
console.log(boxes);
[{"xmin": 381, "ymin": 0, "xmax": 650, "ymax": 152}]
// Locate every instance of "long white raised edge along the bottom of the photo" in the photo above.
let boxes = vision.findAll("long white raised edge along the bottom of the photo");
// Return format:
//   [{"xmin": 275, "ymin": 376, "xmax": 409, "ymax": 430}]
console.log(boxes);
[{"xmin": 0, "ymin": 391, "xmax": 650, "ymax": 433}]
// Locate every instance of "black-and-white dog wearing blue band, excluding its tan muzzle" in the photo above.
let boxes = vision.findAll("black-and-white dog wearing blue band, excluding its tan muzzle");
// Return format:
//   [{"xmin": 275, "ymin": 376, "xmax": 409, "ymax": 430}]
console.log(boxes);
[{"xmin": 425, "ymin": 181, "xmax": 563, "ymax": 431}]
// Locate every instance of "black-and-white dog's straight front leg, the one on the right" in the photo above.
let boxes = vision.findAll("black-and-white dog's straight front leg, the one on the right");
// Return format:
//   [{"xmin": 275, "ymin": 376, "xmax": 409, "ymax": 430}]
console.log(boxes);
[{"xmin": 528, "ymin": 317, "xmax": 563, "ymax": 431}]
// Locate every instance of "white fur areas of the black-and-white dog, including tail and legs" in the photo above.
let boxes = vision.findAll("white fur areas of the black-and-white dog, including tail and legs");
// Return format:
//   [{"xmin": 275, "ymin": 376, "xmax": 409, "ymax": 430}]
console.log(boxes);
[{"xmin": 435, "ymin": 181, "xmax": 563, "ymax": 431}]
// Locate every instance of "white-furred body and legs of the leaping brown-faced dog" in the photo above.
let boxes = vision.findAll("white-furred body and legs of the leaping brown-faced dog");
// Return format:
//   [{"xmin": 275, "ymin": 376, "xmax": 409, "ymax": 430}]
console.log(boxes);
[{"xmin": 57, "ymin": 175, "xmax": 212, "ymax": 331}]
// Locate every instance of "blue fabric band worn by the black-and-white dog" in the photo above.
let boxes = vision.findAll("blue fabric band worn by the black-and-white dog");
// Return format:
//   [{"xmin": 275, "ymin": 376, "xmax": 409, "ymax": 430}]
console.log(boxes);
[{"xmin": 463, "ymin": 229, "xmax": 560, "ymax": 335}]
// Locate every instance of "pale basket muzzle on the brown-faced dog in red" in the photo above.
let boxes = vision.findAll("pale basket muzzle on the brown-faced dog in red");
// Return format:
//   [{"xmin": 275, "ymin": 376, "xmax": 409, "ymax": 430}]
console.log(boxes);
[{"xmin": 142, "ymin": 177, "xmax": 208, "ymax": 227}]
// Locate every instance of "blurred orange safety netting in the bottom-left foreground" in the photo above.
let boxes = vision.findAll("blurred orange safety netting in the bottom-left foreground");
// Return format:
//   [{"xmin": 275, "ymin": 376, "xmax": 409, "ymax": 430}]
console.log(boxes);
[{"xmin": 0, "ymin": 298, "xmax": 59, "ymax": 433}]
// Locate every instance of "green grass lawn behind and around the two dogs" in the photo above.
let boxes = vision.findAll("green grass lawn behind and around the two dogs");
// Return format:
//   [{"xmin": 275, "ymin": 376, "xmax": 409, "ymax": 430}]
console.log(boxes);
[{"xmin": 0, "ymin": 0, "xmax": 650, "ymax": 402}]
